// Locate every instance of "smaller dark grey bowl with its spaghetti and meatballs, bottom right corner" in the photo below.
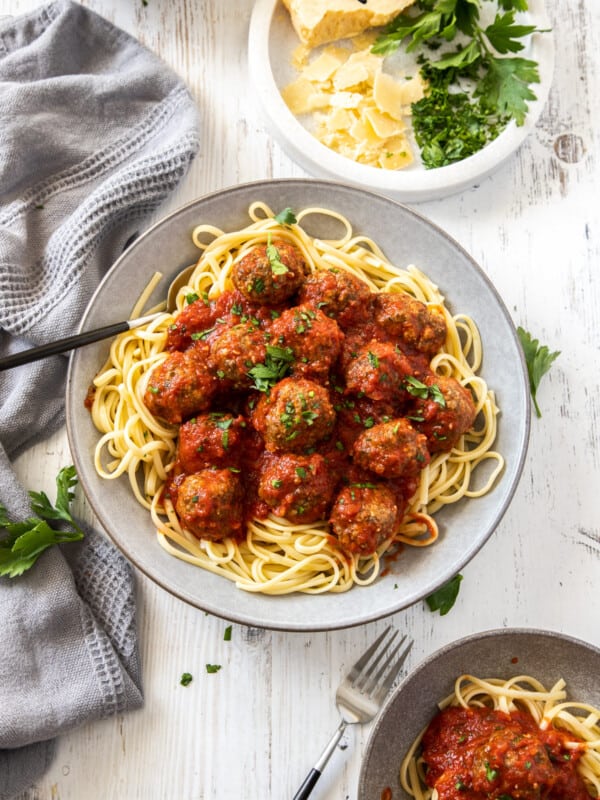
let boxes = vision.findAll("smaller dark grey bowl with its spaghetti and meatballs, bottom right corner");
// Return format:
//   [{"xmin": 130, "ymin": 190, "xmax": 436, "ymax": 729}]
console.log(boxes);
[{"xmin": 358, "ymin": 628, "xmax": 600, "ymax": 800}]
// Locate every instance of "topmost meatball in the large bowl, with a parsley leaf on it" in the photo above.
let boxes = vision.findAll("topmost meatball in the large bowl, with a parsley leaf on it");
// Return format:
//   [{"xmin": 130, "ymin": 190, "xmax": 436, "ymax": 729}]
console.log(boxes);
[{"xmin": 231, "ymin": 239, "xmax": 308, "ymax": 305}]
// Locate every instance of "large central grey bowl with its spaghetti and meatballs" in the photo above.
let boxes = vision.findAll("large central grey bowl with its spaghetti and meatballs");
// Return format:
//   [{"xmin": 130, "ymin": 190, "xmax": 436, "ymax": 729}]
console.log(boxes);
[{"xmin": 67, "ymin": 179, "xmax": 530, "ymax": 630}]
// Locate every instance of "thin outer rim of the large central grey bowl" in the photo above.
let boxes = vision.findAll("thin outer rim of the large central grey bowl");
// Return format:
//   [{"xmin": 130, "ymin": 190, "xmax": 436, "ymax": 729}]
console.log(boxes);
[{"xmin": 65, "ymin": 178, "xmax": 531, "ymax": 631}]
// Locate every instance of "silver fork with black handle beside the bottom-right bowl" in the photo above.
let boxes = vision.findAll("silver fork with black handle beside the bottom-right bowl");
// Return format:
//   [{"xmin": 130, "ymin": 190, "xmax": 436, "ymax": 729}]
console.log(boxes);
[{"xmin": 293, "ymin": 625, "xmax": 412, "ymax": 800}]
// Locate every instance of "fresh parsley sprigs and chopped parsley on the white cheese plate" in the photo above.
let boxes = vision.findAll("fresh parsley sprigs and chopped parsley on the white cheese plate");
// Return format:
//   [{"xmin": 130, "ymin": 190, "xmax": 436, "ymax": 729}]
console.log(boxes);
[{"xmin": 373, "ymin": 0, "xmax": 541, "ymax": 168}]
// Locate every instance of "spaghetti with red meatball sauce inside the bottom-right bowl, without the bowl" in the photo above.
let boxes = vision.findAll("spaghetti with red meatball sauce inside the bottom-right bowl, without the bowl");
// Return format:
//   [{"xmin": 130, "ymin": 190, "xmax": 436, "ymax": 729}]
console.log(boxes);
[{"xmin": 400, "ymin": 675, "xmax": 600, "ymax": 800}]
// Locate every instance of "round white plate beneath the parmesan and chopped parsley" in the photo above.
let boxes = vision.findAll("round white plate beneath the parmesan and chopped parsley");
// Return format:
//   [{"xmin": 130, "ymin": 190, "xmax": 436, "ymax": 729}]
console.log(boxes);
[{"xmin": 248, "ymin": 0, "xmax": 554, "ymax": 202}]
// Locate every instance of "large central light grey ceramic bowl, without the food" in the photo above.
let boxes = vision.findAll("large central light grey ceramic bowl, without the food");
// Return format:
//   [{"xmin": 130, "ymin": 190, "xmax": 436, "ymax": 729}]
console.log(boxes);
[{"xmin": 67, "ymin": 180, "xmax": 530, "ymax": 630}]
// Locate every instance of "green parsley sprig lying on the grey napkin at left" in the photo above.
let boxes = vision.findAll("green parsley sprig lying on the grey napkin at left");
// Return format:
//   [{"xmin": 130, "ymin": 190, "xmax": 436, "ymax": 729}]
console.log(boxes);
[{"xmin": 0, "ymin": 466, "xmax": 84, "ymax": 578}]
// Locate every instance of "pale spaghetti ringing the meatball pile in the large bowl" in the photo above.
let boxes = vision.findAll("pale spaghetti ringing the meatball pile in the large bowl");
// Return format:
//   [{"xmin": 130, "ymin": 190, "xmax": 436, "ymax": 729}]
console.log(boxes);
[{"xmin": 90, "ymin": 202, "xmax": 504, "ymax": 594}]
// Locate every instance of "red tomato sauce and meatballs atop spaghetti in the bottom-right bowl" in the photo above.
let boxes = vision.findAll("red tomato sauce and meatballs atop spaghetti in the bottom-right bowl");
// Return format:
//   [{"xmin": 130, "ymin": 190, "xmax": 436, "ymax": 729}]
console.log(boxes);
[{"xmin": 422, "ymin": 706, "xmax": 591, "ymax": 800}]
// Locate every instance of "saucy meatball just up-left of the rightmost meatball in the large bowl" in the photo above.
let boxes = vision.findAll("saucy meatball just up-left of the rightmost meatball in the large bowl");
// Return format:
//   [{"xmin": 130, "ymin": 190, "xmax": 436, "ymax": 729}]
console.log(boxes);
[{"xmin": 345, "ymin": 340, "xmax": 413, "ymax": 402}]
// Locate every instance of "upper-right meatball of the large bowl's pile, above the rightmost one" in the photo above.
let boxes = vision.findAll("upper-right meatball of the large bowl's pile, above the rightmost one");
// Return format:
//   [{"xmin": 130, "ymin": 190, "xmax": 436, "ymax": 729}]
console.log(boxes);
[{"xmin": 373, "ymin": 292, "xmax": 446, "ymax": 356}]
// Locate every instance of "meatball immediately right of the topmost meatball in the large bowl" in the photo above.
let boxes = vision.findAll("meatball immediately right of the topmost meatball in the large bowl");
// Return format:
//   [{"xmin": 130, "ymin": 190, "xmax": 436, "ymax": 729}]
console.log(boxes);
[{"xmin": 298, "ymin": 269, "xmax": 372, "ymax": 330}]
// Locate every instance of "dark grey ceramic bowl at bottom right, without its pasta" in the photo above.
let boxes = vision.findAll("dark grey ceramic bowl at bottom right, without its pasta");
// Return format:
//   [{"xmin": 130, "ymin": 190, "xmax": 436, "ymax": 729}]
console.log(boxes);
[{"xmin": 358, "ymin": 628, "xmax": 600, "ymax": 800}]
